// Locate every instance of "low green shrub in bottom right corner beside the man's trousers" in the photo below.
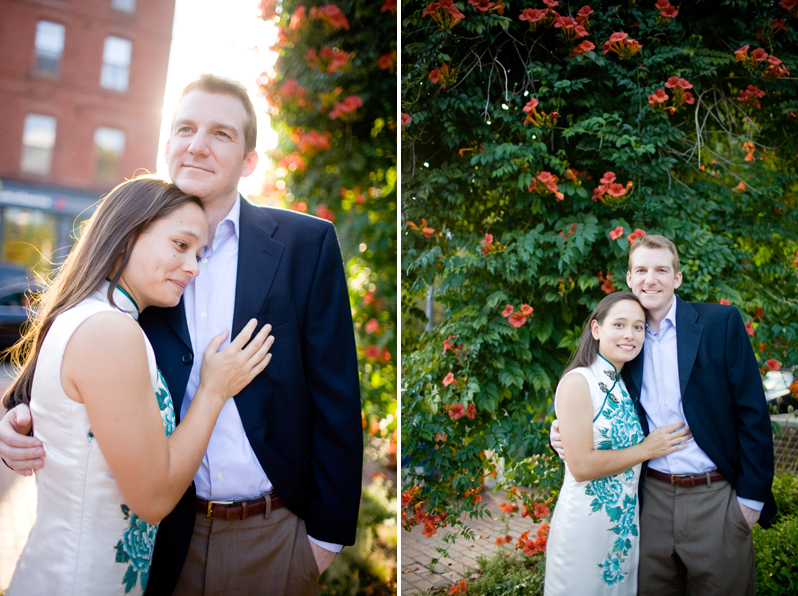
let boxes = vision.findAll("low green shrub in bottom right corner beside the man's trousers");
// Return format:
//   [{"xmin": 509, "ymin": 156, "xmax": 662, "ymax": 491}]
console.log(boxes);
[{"xmin": 754, "ymin": 516, "xmax": 798, "ymax": 596}]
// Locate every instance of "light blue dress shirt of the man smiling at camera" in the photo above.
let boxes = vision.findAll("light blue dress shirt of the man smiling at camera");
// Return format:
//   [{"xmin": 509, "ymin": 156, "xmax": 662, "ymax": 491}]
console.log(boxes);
[{"xmin": 640, "ymin": 298, "xmax": 764, "ymax": 511}]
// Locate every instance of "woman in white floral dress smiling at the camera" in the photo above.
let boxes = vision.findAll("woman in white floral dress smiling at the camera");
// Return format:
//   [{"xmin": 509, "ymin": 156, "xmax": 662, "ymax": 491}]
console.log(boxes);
[{"xmin": 544, "ymin": 292, "xmax": 690, "ymax": 596}]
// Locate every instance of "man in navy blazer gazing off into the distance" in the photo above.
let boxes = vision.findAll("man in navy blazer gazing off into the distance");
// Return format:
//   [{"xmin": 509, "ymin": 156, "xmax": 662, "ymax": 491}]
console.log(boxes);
[{"xmin": 0, "ymin": 75, "xmax": 363, "ymax": 596}]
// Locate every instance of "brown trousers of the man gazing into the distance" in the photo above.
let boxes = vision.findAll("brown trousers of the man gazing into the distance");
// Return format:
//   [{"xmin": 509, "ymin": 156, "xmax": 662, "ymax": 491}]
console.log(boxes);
[{"xmin": 173, "ymin": 507, "xmax": 319, "ymax": 596}]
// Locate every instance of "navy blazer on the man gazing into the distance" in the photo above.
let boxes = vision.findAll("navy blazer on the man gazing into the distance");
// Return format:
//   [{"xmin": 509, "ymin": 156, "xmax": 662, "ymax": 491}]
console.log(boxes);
[{"xmin": 140, "ymin": 199, "xmax": 363, "ymax": 596}]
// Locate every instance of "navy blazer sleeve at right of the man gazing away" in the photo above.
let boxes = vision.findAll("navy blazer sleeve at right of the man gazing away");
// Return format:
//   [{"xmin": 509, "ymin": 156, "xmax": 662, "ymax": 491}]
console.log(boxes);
[{"xmin": 303, "ymin": 225, "xmax": 363, "ymax": 544}]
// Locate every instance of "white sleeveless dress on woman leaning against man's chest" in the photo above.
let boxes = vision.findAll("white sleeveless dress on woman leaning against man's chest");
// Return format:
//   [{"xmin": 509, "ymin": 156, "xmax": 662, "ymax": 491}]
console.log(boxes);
[{"xmin": 6, "ymin": 281, "xmax": 175, "ymax": 596}]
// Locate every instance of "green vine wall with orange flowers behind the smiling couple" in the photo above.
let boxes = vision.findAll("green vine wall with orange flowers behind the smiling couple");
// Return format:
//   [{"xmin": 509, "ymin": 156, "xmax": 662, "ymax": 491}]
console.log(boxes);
[{"xmin": 400, "ymin": 0, "xmax": 798, "ymax": 535}]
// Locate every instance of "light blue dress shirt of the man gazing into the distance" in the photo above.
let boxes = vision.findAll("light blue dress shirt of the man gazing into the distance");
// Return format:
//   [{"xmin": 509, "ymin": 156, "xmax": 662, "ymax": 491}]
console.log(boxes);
[{"xmin": 180, "ymin": 196, "xmax": 342, "ymax": 552}]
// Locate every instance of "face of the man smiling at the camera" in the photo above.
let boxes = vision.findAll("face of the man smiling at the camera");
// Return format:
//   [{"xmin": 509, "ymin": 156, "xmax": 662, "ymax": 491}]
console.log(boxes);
[{"xmin": 626, "ymin": 246, "xmax": 682, "ymax": 319}]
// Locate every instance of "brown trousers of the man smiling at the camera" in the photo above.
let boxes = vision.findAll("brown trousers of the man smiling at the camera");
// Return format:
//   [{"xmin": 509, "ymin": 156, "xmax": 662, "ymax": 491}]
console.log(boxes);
[{"xmin": 637, "ymin": 478, "xmax": 756, "ymax": 596}]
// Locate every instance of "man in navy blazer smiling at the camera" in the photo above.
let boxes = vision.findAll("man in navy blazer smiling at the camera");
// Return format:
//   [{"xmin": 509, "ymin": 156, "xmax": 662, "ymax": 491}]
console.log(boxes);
[{"xmin": 552, "ymin": 235, "xmax": 776, "ymax": 596}]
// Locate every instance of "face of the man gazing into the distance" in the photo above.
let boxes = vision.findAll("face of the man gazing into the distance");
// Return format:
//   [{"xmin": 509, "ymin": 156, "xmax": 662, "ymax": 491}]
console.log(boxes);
[{"xmin": 166, "ymin": 89, "xmax": 258, "ymax": 205}]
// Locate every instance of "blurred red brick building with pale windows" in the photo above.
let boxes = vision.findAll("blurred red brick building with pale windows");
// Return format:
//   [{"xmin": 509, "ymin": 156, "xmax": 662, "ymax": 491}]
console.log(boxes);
[{"xmin": 0, "ymin": 0, "xmax": 175, "ymax": 285}]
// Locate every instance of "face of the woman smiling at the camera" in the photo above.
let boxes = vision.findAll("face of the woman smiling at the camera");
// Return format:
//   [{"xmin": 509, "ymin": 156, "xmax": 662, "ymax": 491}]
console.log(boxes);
[{"xmin": 590, "ymin": 300, "xmax": 646, "ymax": 370}]
